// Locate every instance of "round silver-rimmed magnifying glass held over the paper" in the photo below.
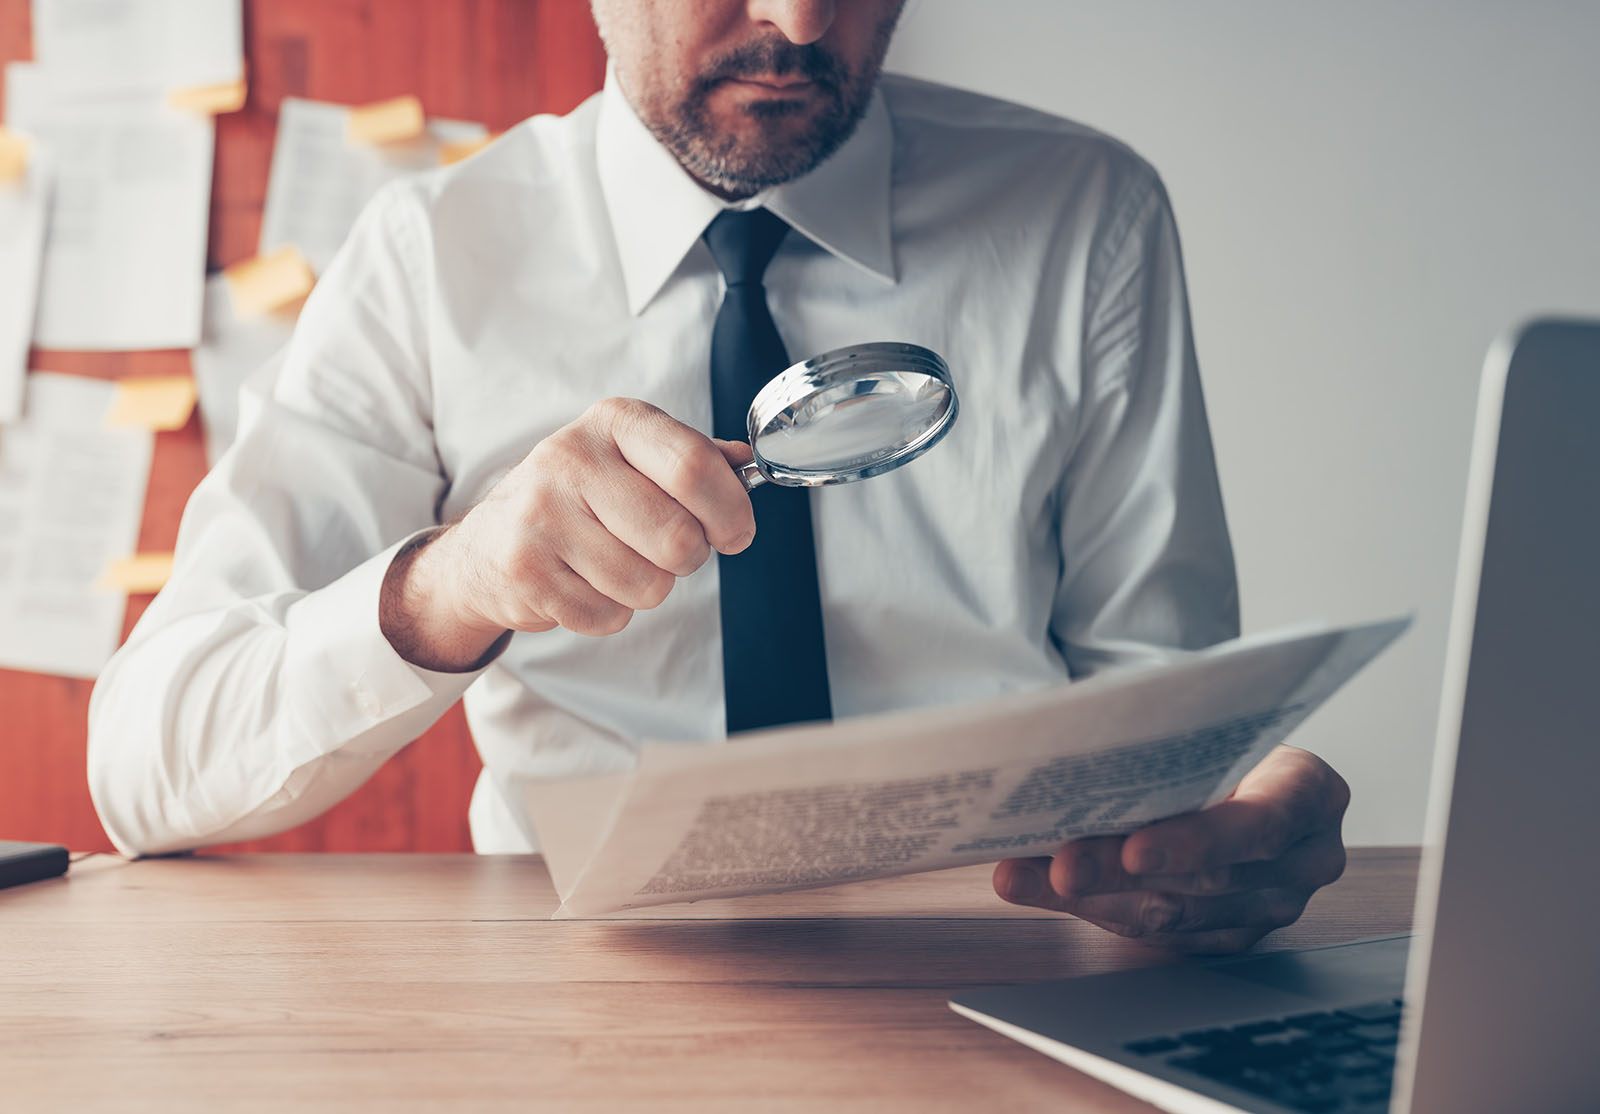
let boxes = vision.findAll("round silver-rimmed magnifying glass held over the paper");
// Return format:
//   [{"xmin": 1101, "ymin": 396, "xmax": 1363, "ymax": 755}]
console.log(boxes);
[{"xmin": 739, "ymin": 341, "xmax": 958, "ymax": 490}]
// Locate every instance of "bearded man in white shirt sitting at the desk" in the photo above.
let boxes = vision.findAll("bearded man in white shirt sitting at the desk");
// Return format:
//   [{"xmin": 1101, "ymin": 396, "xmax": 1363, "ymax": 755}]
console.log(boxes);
[{"xmin": 90, "ymin": 0, "xmax": 1347, "ymax": 951}]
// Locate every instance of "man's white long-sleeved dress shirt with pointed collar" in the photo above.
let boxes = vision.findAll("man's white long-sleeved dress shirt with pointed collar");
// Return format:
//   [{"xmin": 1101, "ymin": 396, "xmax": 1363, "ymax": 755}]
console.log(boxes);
[{"xmin": 90, "ymin": 77, "xmax": 1238, "ymax": 853}]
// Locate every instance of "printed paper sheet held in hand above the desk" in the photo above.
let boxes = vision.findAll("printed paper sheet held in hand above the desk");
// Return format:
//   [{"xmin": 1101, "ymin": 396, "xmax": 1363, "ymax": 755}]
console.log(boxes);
[{"xmin": 525, "ymin": 619, "xmax": 1410, "ymax": 917}]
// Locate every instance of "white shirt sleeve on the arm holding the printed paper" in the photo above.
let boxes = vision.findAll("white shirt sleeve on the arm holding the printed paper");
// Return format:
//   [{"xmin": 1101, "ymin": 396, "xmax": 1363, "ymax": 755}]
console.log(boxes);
[{"xmin": 1051, "ymin": 164, "xmax": 1238, "ymax": 675}]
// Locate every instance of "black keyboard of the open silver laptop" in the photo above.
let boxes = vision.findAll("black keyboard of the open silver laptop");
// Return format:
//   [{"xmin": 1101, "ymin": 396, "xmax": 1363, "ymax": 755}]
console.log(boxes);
[{"xmin": 1125, "ymin": 999, "xmax": 1400, "ymax": 1114}]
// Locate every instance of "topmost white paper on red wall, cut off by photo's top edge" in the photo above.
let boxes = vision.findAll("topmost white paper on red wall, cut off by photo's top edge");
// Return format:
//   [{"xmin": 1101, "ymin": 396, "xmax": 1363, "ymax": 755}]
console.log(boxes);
[{"xmin": 34, "ymin": 0, "xmax": 245, "ymax": 96}]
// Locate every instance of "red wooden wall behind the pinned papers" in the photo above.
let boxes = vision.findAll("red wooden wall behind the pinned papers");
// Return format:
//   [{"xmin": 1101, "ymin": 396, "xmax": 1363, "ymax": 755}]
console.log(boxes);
[{"xmin": 0, "ymin": 0, "xmax": 605, "ymax": 852}]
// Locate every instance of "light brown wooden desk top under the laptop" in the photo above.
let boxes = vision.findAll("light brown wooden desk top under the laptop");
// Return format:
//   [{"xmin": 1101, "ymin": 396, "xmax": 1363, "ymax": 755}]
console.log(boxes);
[{"xmin": 0, "ymin": 848, "xmax": 1416, "ymax": 1114}]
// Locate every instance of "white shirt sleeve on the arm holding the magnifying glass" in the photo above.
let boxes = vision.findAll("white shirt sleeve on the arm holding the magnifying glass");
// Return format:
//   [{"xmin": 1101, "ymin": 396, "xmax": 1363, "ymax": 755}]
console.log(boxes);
[{"xmin": 88, "ymin": 187, "xmax": 477, "ymax": 855}]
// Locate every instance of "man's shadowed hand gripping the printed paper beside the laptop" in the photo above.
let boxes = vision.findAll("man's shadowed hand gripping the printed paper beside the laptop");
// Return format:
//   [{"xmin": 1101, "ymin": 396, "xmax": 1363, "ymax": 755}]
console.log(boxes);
[{"xmin": 994, "ymin": 746, "xmax": 1350, "ymax": 952}]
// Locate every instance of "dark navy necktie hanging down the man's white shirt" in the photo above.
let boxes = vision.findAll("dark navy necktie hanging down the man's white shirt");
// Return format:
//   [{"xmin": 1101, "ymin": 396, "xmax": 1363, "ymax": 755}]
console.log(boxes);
[{"xmin": 706, "ymin": 210, "xmax": 832, "ymax": 735}]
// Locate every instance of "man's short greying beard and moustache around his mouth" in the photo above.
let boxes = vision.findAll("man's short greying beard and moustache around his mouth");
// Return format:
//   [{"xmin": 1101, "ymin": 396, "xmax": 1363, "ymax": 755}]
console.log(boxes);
[{"xmin": 642, "ymin": 32, "xmax": 894, "ymax": 195}]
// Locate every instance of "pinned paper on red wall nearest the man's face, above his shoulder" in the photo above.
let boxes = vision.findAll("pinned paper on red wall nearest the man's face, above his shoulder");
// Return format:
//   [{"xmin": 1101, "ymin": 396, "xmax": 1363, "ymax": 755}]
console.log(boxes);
[{"xmin": 261, "ymin": 96, "xmax": 488, "ymax": 274}]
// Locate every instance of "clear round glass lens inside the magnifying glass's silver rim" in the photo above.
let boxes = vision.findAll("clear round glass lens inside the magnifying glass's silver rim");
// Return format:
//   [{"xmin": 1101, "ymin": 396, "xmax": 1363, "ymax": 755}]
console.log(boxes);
[{"xmin": 755, "ymin": 371, "xmax": 954, "ymax": 474}]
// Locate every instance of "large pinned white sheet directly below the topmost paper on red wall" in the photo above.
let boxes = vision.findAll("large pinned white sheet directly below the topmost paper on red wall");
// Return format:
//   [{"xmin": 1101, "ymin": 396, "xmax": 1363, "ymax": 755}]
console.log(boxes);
[{"xmin": 6, "ymin": 62, "xmax": 213, "ymax": 351}]
